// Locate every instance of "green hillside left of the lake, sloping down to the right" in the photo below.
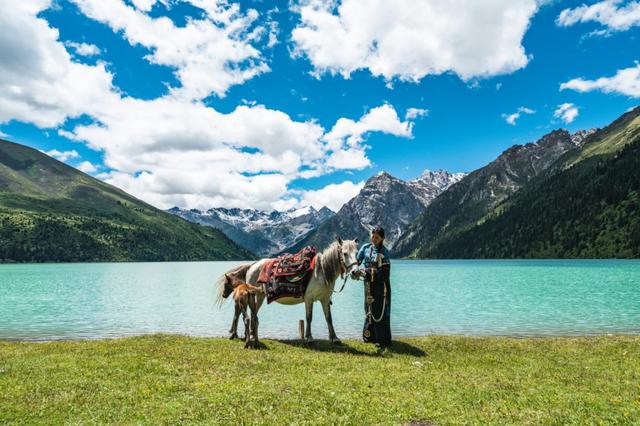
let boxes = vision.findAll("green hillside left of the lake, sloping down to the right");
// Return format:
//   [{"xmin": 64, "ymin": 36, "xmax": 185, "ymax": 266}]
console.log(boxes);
[{"xmin": 0, "ymin": 140, "xmax": 253, "ymax": 262}]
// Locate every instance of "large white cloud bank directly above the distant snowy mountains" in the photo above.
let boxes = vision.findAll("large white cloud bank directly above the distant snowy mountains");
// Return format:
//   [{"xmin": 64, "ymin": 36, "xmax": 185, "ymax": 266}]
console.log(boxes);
[{"xmin": 65, "ymin": 98, "xmax": 411, "ymax": 209}]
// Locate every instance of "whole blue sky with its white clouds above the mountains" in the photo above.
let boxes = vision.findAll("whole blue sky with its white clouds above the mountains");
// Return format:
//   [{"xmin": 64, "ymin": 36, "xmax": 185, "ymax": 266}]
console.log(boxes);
[{"xmin": 0, "ymin": 0, "xmax": 640, "ymax": 210}]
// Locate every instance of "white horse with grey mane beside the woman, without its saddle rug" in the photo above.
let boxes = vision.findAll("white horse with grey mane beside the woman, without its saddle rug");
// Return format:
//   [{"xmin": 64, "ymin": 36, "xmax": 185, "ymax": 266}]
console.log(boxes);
[{"xmin": 217, "ymin": 238, "xmax": 358, "ymax": 344}]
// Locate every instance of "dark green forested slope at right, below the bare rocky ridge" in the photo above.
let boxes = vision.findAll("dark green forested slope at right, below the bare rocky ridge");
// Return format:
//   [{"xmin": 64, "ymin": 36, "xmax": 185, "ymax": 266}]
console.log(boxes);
[{"xmin": 415, "ymin": 108, "xmax": 640, "ymax": 258}]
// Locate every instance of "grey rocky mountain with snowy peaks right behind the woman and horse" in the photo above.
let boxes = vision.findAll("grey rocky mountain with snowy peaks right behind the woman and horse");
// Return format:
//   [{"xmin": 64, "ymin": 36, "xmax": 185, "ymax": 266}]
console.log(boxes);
[{"xmin": 280, "ymin": 170, "xmax": 465, "ymax": 252}]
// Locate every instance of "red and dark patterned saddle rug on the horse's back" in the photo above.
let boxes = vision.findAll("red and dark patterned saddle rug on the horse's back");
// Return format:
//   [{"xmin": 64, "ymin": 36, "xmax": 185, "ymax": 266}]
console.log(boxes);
[{"xmin": 258, "ymin": 246, "xmax": 317, "ymax": 303}]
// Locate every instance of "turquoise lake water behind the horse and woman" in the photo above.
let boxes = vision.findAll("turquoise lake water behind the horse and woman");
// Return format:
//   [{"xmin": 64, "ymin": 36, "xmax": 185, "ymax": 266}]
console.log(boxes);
[{"xmin": 0, "ymin": 260, "xmax": 640, "ymax": 339}]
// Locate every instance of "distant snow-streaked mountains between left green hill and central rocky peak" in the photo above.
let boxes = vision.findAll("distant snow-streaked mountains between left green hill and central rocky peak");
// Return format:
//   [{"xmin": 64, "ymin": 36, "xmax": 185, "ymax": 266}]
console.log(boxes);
[{"xmin": 167, "ymin": 206, "xmax": 334, "ymax": 256}]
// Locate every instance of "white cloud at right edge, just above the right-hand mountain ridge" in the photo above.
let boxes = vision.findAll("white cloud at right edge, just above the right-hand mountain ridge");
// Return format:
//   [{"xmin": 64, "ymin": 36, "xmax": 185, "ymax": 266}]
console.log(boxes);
[{"xmin": 560, "ymin": 63, "xmax": 640, "ymax": 98}]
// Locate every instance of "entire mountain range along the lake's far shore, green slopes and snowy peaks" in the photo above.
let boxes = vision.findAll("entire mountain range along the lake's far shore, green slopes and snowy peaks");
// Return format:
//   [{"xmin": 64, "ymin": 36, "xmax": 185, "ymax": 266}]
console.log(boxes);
[{"xmin": 0, "ymin": 107, "xmax": 640, "ymax": 261}]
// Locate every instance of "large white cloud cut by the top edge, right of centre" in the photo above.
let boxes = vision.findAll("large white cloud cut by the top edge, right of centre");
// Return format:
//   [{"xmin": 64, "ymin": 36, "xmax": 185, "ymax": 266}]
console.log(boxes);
[{"xmin": 292, "ymin": 0, "xmax": 539, "ymax": 82}]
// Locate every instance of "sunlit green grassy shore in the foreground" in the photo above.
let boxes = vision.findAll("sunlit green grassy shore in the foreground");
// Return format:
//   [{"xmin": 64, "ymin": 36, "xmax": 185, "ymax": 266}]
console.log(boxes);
[{"xmin": 0, "ymin": 335, "xmax": 640, "ymax": 425}]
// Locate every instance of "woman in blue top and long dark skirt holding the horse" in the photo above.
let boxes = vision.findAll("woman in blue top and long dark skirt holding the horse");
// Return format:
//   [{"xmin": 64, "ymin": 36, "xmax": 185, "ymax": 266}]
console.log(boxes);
[{"xmin": 356, "ymin": 226, "xmax": 391, "ymax": 353}]
